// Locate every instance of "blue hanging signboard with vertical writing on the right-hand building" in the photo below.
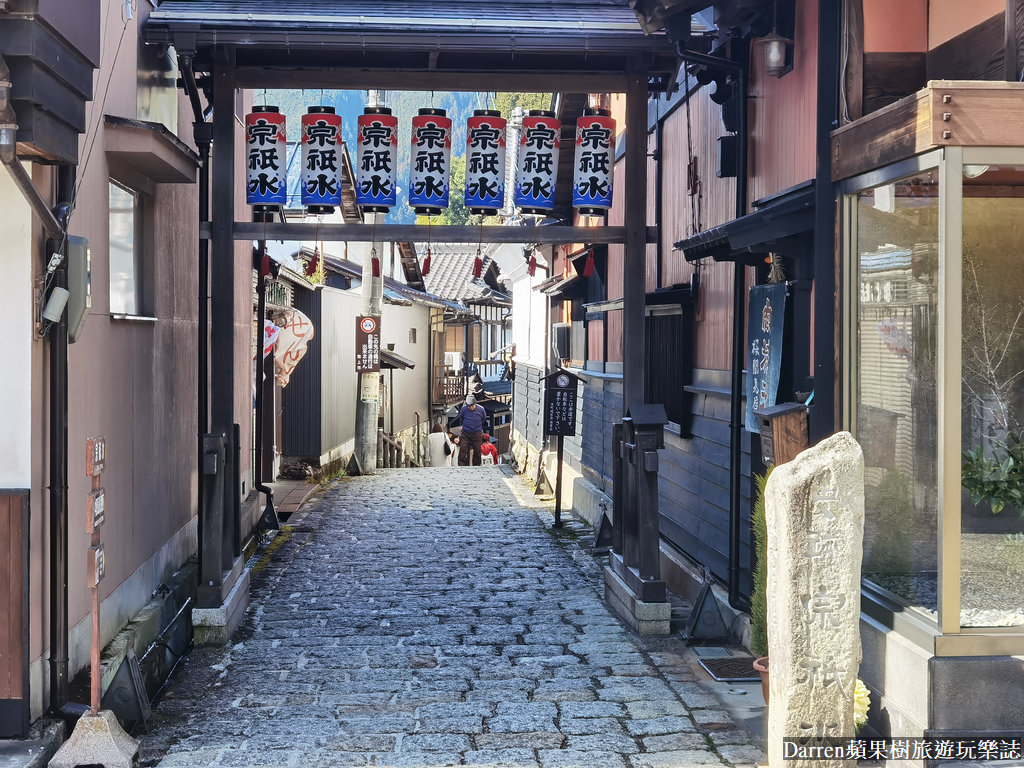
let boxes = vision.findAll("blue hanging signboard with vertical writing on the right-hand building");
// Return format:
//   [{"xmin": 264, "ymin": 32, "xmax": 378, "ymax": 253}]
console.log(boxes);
[{"xmin": 746, "ymin": 283, "xmax": 785, "ymax": 433}]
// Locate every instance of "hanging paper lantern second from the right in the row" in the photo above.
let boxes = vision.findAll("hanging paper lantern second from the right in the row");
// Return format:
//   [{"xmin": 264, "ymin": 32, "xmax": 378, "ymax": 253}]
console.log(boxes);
[{"xmin": 515, "ymin": 110, "xmax": 562, "ymax": 216}]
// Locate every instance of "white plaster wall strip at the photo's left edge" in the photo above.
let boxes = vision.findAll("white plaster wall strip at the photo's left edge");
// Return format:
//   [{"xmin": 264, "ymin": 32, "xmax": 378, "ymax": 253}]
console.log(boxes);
[{"xmin": 0, "ymin": 166, "xmax": 36, "ymax": 488}]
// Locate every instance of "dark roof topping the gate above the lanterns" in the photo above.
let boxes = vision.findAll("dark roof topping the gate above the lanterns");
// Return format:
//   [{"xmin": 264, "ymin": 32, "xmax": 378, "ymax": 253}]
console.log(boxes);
[{"xmin": 142, "ymin": 0, "xmax": 678, "ymax": 89}]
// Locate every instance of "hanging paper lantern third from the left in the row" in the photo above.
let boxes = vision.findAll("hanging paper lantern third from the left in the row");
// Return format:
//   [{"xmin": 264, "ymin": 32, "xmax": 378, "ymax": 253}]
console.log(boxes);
[{"xmin": 355, "ymin": 106, "xmax": 398, "ymax": 213}]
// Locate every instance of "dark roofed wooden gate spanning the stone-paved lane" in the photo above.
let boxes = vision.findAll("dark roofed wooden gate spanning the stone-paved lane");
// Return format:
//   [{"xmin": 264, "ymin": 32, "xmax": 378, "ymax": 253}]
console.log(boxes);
[{"xmin": 143, "ymin": 0, "xmax": 679, "ymax": 607}]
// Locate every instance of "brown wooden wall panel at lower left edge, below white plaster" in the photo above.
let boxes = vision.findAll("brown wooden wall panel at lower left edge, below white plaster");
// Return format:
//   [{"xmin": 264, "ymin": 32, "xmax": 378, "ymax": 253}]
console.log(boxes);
[{"xmin": 0, "ymin": 489, "xmax": 29, "ymax": 738}]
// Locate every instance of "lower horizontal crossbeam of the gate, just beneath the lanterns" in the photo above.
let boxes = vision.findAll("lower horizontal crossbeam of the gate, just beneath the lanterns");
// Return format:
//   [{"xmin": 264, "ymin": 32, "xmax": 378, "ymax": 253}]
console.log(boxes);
[{"xmin": 200, "ymin": 221, "xmax": 657, "ymax": 245}]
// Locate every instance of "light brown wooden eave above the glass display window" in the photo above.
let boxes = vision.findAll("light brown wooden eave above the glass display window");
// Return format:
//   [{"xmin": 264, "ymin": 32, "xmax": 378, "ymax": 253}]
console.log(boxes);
[{"xmin": 831, "ymin": 80, "xmax": 1024, "ymax": 181}]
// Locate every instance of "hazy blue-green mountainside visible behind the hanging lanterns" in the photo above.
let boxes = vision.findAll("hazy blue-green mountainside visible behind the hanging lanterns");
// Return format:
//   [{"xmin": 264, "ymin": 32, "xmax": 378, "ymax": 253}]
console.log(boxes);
[{"xmin": 266, "ymin": 90, "xmax": 485, "ymax": 224}]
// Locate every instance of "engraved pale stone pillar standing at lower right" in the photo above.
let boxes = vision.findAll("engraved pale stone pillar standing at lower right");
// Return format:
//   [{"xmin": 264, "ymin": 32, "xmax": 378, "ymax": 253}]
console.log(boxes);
[{"xmin": 765, "ymin": 432, "xmax": 864, "ymax": 768}]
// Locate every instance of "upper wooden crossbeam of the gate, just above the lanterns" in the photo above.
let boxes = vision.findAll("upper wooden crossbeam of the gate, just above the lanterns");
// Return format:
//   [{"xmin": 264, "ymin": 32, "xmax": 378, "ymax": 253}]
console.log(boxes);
[{"xmin": 236, "ymin": 67, "xmax": 626, "ymax": 93}]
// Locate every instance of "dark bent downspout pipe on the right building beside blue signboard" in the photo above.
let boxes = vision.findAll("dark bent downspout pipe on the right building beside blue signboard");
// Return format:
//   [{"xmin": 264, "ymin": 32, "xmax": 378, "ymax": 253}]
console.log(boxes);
[{"xmin": 670, "ymin": 39, "xmax": 751, "ymax": 611}]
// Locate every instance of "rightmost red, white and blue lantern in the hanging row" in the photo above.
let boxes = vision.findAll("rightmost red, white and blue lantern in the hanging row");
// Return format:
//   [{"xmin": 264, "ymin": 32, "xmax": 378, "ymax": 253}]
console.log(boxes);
[{"xmin": 572, "ymin": 106, "xmax": 615, "ymax": 216}]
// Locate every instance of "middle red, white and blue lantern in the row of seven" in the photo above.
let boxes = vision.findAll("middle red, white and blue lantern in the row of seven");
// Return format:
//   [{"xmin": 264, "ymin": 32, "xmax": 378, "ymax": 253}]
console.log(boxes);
[{"xmin": 409, "ymin": 109, "xmax": 452, "ymax": 216}]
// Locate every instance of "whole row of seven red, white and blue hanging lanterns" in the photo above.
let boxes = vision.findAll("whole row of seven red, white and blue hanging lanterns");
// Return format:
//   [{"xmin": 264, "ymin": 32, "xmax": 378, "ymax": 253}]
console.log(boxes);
[{"xmin": 246, "ymin": 106, "xmax": 615, "ymax": 215}]
